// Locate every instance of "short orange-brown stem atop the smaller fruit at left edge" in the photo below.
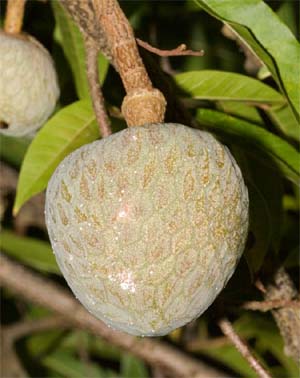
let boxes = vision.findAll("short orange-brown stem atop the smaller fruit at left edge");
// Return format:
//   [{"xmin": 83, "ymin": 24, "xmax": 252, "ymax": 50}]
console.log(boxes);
[{"xmin": 4, "ymin": 0, "xmax": 26, "ymax": 34}]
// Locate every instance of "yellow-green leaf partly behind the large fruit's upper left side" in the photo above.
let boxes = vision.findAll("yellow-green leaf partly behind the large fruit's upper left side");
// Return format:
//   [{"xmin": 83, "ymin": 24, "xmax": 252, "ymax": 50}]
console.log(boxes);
[{"xmin": 14, "ymin": 100, "xmax": 99, "ymax": 214}]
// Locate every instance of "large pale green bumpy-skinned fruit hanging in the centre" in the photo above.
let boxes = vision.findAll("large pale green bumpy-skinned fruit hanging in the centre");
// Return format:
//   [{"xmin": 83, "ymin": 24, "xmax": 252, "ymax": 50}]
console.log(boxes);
[{"xmin": 46, "ymin": 124, "xmax": 248, "ymax": 336}]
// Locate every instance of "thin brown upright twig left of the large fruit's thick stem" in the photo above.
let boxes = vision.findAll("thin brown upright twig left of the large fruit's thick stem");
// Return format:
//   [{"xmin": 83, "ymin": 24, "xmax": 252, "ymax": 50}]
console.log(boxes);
[{"xmin": 85, "ymin": 37, "xmax": 112, "ymax": 138}]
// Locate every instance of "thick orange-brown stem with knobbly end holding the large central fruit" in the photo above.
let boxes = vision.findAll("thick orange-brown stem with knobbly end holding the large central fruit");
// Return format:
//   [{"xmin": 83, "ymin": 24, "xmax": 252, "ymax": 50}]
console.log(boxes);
[{"xmin": 93, "ymin": 0, "xmax": 166, "ymax": 126}]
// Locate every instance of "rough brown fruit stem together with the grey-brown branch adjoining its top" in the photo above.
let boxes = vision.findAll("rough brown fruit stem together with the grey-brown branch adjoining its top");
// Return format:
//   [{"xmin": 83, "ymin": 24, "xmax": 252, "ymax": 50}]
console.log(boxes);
[{"xmin": 61, "ymin": 0, "xmax": 166, "ymax": 126}]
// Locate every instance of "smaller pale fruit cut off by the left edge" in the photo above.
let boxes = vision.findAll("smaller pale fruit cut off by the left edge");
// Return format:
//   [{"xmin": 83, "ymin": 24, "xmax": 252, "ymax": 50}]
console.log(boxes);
[{"xmin": 0, "ymin": 32, "xmax": 59, "ymax": 136}]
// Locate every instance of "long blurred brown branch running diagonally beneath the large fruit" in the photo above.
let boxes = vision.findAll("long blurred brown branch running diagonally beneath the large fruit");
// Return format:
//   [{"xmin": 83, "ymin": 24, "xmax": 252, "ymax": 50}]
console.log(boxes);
[{"xmin": 0, "ymin": 256, "xmax": 224, "ymax": 378}]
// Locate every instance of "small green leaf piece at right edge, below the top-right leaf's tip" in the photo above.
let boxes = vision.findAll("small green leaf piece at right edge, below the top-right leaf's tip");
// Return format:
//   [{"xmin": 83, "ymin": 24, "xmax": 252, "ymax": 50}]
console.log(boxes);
[{"xmin": 267, "ymin": 106, "xmax": 300, "ymax": 142}]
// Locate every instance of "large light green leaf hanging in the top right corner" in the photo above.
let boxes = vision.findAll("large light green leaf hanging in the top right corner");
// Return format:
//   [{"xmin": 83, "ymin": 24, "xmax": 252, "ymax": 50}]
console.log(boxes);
[{"xmin": 195, "ymin": 0, "xmax": 300, "ymax": 119}]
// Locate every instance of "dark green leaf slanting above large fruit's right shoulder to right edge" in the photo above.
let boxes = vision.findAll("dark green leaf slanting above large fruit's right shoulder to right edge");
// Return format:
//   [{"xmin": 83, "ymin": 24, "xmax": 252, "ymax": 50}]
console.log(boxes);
[{"xmin": 197, "ymin": 109, "xmax": 300, "ymax": 185}]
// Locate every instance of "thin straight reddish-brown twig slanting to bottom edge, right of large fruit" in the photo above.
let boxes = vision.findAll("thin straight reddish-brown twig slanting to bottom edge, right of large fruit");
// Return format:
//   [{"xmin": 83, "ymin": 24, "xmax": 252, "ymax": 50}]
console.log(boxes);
[{"xmin": 219, "ymin": 318, "xmax": 271, "ymax": 378}]
